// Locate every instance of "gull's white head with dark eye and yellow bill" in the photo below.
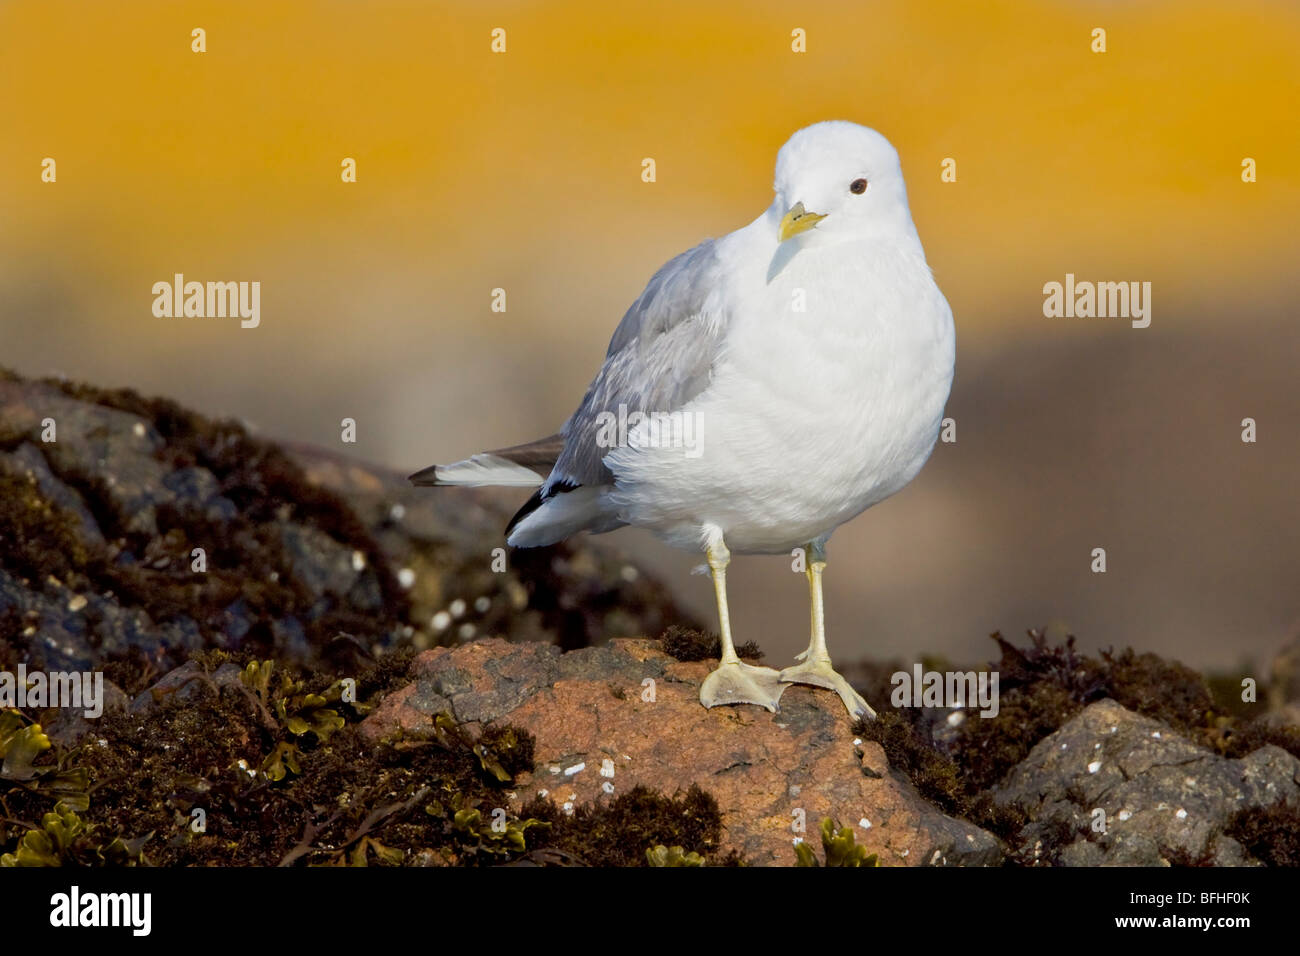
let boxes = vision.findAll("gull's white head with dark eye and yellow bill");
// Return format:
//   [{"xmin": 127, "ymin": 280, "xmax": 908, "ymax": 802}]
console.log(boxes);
[{"xmin": 772, "ymin": 120, "xmax": 915, "ymax": 243}]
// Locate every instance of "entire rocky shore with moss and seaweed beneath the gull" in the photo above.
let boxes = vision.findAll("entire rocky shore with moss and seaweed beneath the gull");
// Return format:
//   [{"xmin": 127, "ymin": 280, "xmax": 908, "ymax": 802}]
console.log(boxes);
[{"xmin": 0, "ymin": 369, "xmax": 1300, "ymax": 866}]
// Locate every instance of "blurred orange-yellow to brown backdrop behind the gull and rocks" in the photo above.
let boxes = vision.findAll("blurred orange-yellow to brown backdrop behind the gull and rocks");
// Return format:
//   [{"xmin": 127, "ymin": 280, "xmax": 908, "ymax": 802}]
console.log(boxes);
[{"xmin": 0, "ymin": 0, "xmax": 1300, "ymax": 669}]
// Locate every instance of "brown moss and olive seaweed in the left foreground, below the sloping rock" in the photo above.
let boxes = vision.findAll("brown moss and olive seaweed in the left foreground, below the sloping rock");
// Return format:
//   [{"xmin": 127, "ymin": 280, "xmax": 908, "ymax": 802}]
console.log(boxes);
[{"xmin": 0, "ymin": 650, "xmax": 737, "ymax": 866}]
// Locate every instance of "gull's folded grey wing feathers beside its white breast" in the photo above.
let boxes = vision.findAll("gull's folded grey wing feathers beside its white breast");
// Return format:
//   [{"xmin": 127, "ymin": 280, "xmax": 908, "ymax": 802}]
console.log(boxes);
[{"xmin": 541, "ymin": 239, "xmax": 728, "ymax": 498}]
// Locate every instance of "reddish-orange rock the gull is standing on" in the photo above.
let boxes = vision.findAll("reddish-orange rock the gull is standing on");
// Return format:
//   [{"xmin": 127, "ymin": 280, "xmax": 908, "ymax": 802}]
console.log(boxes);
[{"xmin": 361, "ymin": 640, "xmax": 1002, "ymax": 866}]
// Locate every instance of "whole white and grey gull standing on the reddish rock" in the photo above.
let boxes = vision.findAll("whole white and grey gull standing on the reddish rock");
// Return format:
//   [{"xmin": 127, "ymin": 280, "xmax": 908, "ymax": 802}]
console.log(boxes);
[{"xmin": 411, "ymin": 121, "xmax": 956, "ymax": 718}]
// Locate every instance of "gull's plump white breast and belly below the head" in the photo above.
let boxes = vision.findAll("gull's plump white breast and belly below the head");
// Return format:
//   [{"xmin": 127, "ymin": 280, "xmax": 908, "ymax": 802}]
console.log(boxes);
[{"xmin": 606, "ymin": 231, "xmax": 954, "ymax": 553}]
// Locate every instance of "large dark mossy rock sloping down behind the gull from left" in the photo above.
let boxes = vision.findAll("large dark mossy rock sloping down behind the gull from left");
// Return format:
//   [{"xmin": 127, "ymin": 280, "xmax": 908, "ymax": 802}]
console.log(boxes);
[{"xmin": 0, "ymin": 369, "xmax": 689, "ymax": 691}]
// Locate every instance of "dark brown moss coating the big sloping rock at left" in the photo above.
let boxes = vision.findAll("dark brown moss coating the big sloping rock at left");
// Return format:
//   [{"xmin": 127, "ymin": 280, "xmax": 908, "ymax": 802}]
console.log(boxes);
[{"xmin": 0, "ymin": 380, "xmax": 410, "ymax": 667}]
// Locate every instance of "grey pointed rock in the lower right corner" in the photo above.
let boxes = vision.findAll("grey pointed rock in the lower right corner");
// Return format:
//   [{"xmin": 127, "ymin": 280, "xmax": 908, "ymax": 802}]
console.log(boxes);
[{"xmin": 993, "ymin": 700, "xmax": 1300, "ymax": 866}]
